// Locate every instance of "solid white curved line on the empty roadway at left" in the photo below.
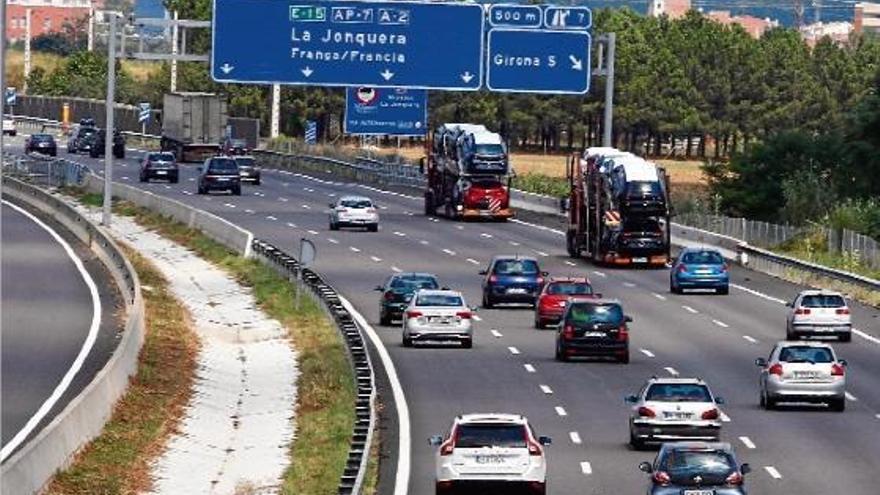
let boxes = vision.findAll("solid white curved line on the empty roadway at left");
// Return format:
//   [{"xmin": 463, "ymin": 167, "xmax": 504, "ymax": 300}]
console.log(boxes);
[{"xmin": 0, "ymin": 200, "xmax": 102, "ymax": 461}]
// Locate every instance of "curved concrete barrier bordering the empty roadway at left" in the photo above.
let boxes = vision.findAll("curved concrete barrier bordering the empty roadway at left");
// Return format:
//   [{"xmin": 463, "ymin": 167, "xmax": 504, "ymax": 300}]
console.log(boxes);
[{"xmin": 0, "ymin": 178, "xmax": 145, "ymax": 495}]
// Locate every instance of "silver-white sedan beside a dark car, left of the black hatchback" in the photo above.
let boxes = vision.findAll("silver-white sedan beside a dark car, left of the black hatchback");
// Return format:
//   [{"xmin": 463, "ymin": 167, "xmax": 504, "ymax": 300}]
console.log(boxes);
[{"xmin": 403, "ymin": 289, "xmax": 474, "ymax": 349}]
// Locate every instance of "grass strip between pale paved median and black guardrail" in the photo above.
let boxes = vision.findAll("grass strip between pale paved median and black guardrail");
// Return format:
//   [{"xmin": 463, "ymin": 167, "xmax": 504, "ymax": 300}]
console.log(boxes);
[{"xmin": 62, "ymin": 191, "xmax": 378, "ymax": 495}]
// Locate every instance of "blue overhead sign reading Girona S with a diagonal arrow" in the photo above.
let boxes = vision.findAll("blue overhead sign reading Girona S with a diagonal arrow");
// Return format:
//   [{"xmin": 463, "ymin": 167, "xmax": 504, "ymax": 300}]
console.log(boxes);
[{"xmin": 486, "ymin": 29, "xmax": 590, "ymax": 94}]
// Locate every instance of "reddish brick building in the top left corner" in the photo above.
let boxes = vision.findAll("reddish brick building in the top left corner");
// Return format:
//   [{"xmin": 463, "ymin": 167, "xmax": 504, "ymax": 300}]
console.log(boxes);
[{"xmin": 4, "ymin": 0, "xmax": 92, "ymax": 42}]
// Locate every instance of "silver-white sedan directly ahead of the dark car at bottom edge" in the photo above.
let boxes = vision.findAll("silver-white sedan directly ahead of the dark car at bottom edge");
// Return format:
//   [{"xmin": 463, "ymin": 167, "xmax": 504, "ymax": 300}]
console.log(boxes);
[{"xmin": 626, "ymin": 377, "xmax": 724, "ymax": 450}]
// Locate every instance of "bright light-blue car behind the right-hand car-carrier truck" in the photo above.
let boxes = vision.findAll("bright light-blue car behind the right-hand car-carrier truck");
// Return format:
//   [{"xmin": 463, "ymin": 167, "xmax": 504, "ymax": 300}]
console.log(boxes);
[{"xmin": 669, "ymin": 248, "xmax": 730, "ymax": 294}]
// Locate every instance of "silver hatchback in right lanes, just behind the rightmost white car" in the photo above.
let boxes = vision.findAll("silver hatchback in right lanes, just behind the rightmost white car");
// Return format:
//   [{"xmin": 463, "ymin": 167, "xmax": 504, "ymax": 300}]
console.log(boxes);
[{"xmin": 755, "ymin": 342, "xmax": 846, "ymax": 411}]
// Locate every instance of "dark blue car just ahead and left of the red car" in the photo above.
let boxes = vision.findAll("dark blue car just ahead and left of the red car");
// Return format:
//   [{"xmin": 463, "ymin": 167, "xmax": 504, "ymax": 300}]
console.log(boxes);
[{"xmin": 480, "ymin": 255, "xmax": 547, "ymax": 308}]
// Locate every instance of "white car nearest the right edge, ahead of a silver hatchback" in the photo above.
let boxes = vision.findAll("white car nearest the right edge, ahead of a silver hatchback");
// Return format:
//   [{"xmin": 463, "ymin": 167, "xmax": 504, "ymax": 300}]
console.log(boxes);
[{"xmin": 785, "ymin": 290, "xmax": 852, "ymax": 342}]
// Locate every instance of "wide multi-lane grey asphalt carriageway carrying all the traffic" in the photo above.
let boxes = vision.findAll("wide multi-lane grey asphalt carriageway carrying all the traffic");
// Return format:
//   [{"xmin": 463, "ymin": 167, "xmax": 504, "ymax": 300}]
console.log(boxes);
[{"xmin": 13, "ymin": 140, "xmax": 880, "ymax": 495}]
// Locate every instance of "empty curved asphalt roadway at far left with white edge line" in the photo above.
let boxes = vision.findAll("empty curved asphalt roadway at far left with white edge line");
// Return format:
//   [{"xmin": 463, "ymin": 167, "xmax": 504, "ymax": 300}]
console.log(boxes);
[{"xmin": 0, "ymin": 200, "xmax": 118, "ymax": 454}]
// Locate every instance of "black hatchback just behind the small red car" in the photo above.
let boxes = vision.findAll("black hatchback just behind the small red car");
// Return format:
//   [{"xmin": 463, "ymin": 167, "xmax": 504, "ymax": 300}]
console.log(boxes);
[{"xmin": 556, "ymin": 299, "xmax": 632, "ymax": 363}]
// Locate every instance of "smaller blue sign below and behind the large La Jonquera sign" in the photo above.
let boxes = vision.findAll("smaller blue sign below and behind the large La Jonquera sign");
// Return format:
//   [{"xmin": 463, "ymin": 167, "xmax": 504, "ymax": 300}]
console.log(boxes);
[{"xmin": 343, "ymin": 87, "xmax": 428, "ymax": 136}]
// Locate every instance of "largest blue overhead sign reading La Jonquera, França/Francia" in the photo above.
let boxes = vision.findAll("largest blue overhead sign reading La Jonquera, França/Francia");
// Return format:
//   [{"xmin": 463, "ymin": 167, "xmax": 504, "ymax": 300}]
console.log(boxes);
[{"xmin": 211, "ymin": 0, "xmax": 484, "ymax": 90}]
